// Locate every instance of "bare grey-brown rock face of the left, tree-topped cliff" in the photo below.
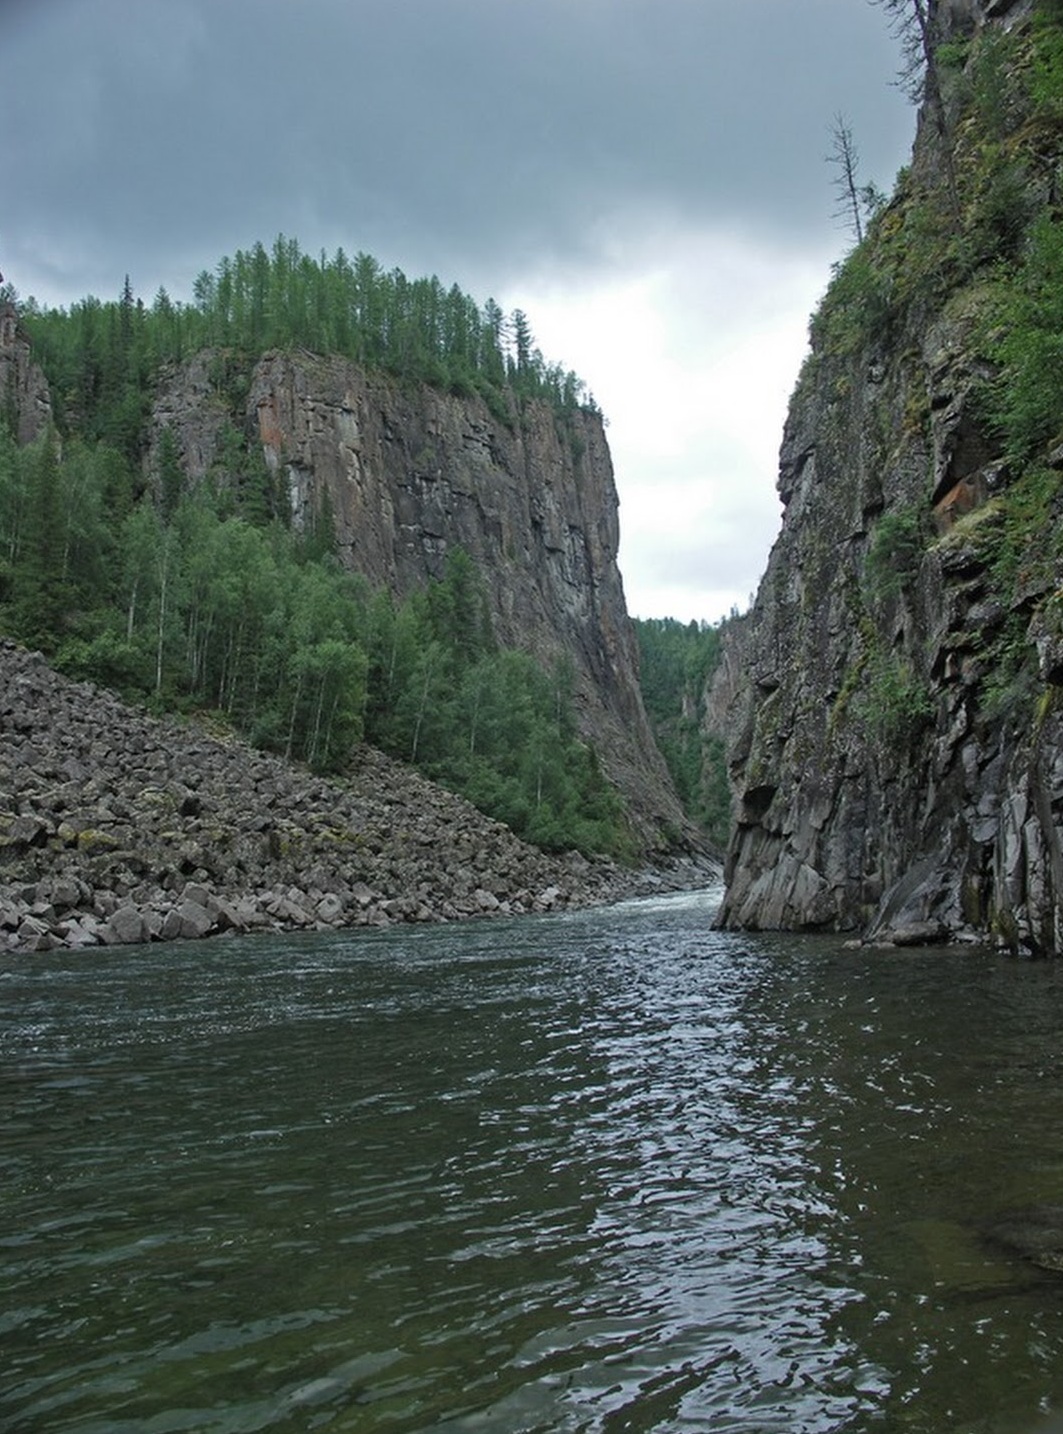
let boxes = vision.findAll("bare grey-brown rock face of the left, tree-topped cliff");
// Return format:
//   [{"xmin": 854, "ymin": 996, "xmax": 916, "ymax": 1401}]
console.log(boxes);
[{"xmin": 153, "ymin": 350, "xmax": 690, "ymax": 847}]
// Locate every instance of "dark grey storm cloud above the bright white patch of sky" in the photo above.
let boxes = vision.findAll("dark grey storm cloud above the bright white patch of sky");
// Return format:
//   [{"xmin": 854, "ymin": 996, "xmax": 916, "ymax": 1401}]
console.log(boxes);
[{"xmin": 0, "ymin": 0, "xmax": 911, "ymax": 298}]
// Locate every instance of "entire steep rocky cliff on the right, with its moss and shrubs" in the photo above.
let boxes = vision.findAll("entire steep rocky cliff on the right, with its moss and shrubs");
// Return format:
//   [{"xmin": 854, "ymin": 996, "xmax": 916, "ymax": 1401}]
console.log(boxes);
[{"xmin": 722, "ymin": 0, "xmax": 1063, "ymax": 952}]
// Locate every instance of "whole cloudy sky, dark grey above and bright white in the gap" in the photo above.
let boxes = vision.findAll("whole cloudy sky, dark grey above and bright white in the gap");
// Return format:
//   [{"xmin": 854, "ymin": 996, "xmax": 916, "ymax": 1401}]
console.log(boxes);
[{"xmin": 0, "ymin": 0, "xmax": 914, "ymax": 621}]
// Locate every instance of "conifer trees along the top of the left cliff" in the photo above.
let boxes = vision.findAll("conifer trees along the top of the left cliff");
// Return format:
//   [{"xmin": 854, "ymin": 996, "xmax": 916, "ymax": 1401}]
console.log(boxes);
[{"xmin": 10, "ymin": 235, "xmax": 598, "ymax": 459}]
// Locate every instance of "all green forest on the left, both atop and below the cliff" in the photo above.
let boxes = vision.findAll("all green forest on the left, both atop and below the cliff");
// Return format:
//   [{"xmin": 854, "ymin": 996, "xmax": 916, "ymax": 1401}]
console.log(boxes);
[{"xmin": 0, "ymin": 239, "xmax": 631, "ymax": 858}]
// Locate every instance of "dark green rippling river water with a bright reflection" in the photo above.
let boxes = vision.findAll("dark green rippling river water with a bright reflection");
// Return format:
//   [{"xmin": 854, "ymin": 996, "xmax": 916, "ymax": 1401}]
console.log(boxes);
[{"xmin": 0, "ymin": 893, "xmax": 1063, "ymax": 1434}]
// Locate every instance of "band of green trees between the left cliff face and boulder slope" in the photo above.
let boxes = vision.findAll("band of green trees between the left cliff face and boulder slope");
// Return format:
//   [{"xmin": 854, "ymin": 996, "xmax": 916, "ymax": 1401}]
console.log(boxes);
[{"xmin": 0, "ymin": 422, "xmax": 628, "ymax": 855}]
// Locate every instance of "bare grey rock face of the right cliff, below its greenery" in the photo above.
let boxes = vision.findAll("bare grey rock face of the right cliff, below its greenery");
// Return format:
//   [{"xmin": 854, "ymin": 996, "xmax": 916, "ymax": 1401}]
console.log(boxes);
[{"xmin": 720, "ymin": 4, "xmax": 1063, "ymax": 954}]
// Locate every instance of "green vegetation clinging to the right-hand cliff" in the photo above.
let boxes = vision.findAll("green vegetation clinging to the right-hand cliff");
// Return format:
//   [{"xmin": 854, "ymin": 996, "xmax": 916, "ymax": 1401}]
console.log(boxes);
[{"xmin": 809, "ymin": 0, "xmax": 1063, "ymax": 751}]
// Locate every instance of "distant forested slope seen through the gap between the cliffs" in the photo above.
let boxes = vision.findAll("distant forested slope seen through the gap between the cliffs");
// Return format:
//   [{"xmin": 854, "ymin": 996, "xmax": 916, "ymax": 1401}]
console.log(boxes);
[{"xmin": 636, "ymin": 618, "xmax": 732, "ymax": 846}]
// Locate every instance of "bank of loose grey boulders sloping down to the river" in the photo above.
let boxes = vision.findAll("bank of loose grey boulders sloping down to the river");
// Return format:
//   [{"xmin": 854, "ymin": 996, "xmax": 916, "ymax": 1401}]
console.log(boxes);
[{"xmin": 0, "ymin": 640, "xmax": 716, "ymax": 952}]
